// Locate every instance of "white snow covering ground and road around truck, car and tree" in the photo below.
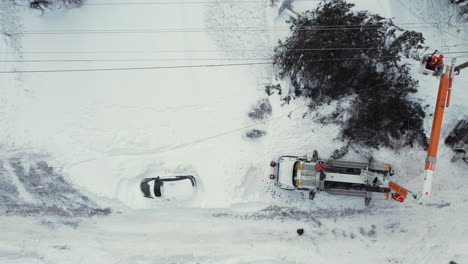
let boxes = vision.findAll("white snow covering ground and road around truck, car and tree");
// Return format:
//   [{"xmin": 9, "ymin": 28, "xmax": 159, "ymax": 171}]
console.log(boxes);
[{"xmin": 0, "ymin": 0, "xmax": 468, "ymax": 264}]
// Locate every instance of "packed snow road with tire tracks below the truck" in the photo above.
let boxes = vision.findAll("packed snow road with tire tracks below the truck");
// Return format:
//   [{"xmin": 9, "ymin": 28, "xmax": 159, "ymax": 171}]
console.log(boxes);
[{"xmin": 0, "ymin": 205, "xmax": 467, "ymax": 264}]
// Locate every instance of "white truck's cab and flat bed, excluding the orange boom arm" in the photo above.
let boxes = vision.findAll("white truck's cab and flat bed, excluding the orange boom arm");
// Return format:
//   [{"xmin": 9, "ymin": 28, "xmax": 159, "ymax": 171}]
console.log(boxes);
[{"xmin": 270, "ymin": 151, "xmax": 393, "ymax": 205}]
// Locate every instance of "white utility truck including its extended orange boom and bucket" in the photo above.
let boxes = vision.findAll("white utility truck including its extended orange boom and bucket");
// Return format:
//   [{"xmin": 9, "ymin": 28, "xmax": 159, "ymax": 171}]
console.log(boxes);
[{"xmin": 270, "ymin": 58, "xmax": 468, "ymax": 205}]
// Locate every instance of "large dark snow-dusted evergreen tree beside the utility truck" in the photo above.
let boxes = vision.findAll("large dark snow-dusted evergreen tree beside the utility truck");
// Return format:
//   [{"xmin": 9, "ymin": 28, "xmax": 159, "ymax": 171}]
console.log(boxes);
[{"xmin": 267, "ymin": 0, "xmax": 427, "ymax": 148}]
